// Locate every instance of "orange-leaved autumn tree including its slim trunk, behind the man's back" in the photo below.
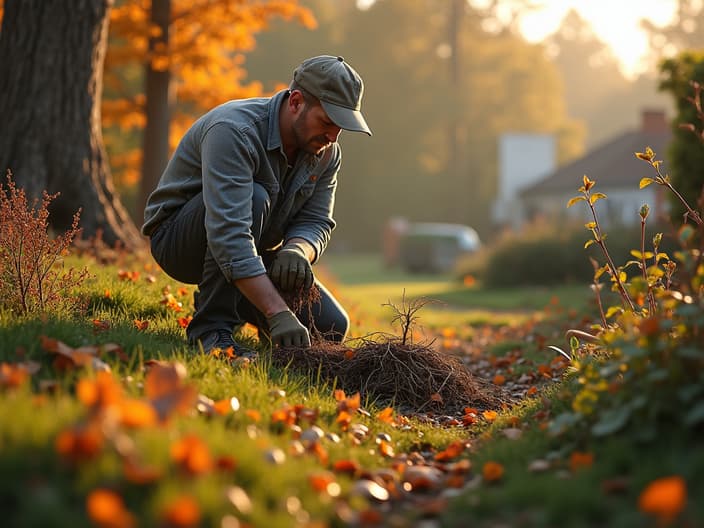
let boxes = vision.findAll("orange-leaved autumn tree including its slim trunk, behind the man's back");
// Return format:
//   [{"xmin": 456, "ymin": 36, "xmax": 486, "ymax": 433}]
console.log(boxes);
[{"xmin": 103, "ymin": 0, "xmax": 315, "ymax": 219}]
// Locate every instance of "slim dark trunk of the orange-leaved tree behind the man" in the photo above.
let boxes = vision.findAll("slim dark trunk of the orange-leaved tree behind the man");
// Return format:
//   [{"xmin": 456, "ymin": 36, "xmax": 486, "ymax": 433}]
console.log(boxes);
[{"xmin": 137, "ymin": 0, "xmax": 173, "ymax": 217}]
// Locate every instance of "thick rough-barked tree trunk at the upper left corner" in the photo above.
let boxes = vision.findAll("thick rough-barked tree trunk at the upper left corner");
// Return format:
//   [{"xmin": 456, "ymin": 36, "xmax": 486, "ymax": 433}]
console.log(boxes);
[{"xmin": 0, "ymin": 0, "xmax": 144, "ymax": 249}]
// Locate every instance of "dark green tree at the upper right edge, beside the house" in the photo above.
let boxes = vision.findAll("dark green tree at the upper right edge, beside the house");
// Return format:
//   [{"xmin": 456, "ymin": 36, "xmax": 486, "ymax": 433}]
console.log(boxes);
[{"xmin": 657, "ymin": 51, "xmax": 704, "ymax": 222}]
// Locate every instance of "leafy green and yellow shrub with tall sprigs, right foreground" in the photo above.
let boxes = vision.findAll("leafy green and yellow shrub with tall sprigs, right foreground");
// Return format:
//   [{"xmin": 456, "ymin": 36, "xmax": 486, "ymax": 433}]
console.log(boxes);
[{"xmin": 552, "ymin": 144, "xmax": 704, "ymax": 441}]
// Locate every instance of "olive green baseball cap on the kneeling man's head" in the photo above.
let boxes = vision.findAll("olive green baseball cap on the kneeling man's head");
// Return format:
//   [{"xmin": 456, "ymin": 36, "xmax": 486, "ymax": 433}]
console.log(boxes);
[{"xmin": 293, "ymin": 55, "xmax": 372, "ymax": 136}]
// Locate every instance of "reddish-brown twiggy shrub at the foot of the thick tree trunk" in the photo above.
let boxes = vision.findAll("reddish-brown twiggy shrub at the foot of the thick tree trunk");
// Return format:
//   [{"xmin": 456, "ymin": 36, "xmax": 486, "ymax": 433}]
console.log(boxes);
[{"xmin": 0, "ymin": 171, "xmax": 88, "ymax": 314}]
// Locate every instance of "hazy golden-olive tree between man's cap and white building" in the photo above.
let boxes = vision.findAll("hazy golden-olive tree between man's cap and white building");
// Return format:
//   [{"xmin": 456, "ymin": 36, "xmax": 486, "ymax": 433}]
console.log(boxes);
[{"xmin": 247, "ymin": 0, "xmax": 581, "ymax": 250}]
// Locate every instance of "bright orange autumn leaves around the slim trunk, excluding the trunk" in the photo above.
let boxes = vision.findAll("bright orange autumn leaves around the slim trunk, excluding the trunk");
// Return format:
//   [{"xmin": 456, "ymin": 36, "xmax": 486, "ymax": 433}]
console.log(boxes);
[{"xmin": 102, "ymin": 0, "xmax": 316, "ymax": 184}]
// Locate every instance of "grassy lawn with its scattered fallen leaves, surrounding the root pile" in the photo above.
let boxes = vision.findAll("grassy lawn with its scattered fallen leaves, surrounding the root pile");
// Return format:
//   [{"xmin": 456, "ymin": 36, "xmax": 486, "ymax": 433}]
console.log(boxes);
[{"xmin": 0, "ymin": 249, "xmax": 704, "ymax": 527}]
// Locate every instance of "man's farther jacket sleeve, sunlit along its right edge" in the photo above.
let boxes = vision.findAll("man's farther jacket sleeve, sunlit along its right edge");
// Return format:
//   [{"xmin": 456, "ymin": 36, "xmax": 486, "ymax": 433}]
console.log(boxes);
[{"xmin": 286, "ymin": 144, "xmax": 342, "ymax": 262}]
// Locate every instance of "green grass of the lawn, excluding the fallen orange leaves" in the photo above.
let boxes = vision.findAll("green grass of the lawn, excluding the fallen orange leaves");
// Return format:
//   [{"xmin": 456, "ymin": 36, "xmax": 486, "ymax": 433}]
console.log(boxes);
[{"xmin": 0, "ymin": 256, "xmax": 704, "ymax": 528}]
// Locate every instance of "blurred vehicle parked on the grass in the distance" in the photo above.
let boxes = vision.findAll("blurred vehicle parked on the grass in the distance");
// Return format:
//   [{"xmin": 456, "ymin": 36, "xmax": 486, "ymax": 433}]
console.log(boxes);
[{"xmin": 399, "ymin": 222, "xmax": 481, "ymax": 273}]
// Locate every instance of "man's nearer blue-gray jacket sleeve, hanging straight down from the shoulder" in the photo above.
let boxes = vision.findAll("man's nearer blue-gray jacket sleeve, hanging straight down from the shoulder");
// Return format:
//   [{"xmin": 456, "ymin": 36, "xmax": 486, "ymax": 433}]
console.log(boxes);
[{"xmin": 201, "ymin": 122, "xmax": 266, "ymax": 281}]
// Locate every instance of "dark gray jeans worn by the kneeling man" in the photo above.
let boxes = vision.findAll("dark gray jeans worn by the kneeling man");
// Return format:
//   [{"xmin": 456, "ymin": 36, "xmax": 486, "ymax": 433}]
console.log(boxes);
[{"xmin": 151, "ymin": 183, "xmax": 350, "ymax": 343}]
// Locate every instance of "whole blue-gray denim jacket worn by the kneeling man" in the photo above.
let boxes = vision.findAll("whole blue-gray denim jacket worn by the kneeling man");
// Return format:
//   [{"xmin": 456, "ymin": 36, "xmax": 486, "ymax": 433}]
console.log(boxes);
[{"xmin": 142, "ymin": 90, "xmax": 341, "ymax": 281}]
